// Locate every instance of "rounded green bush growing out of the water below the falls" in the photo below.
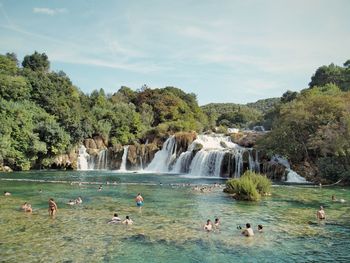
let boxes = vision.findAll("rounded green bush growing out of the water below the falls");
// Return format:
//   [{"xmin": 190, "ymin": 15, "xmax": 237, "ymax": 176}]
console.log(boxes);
[{"xmin": 224, "ymin": 171, "xmax": 271, "ymax": 201}]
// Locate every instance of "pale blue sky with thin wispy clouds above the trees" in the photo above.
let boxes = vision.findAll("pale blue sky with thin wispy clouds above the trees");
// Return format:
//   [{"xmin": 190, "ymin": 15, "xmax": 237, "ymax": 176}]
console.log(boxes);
[{"xmin": 0, "ymin": 0, "xmax": 350, "ymax": 105}]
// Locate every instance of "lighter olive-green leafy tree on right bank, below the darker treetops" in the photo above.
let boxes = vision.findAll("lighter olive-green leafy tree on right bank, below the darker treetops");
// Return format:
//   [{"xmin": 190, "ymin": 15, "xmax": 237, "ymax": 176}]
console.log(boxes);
[{"xmin": 258, "ymin": 84, "xmax": 350, "ymax": 184}]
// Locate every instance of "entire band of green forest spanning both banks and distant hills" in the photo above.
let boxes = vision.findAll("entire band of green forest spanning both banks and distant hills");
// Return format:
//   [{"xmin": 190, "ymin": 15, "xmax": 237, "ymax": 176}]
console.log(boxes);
[{"xmin": 0, "ymin": 52, "xmax": 350, "ymax": 184}]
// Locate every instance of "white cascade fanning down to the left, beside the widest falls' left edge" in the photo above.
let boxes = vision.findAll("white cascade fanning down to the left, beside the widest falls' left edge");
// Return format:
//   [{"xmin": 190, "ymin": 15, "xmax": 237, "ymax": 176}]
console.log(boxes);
[{"xmin": 146, "ymin": 136, "xmax": 176, "ymax": 173}]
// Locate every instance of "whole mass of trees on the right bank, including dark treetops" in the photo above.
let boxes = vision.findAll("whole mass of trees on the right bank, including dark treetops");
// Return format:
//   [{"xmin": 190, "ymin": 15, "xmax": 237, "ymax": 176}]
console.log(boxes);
[{"xmin": 258, "ymin": 60, "xmax": 350, "ymax": 182}]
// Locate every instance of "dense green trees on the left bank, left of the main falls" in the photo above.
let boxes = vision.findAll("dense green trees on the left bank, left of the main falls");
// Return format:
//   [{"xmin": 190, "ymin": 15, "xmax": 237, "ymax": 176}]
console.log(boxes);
[{"xmin": 0, "ymin": 52, "xmax": 208, "ymax": 170}]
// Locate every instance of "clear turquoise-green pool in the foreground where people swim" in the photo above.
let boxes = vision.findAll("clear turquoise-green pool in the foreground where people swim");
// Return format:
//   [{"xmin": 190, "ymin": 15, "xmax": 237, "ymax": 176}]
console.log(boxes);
[{"xmin": 0, "ymin": 171, "xmax": 350, "ymax": 262}]
